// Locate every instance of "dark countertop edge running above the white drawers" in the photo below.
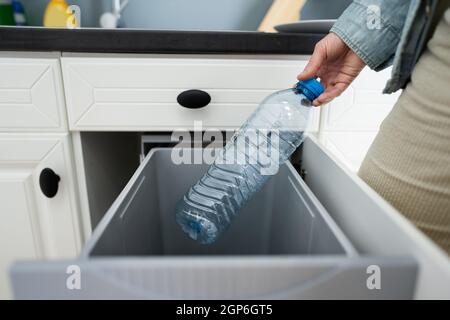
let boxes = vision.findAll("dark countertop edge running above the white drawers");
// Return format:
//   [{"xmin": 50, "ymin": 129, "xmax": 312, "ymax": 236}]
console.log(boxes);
[{"xmin": 0, "ymin": 27, "xmax": 325, "ymax": 54}]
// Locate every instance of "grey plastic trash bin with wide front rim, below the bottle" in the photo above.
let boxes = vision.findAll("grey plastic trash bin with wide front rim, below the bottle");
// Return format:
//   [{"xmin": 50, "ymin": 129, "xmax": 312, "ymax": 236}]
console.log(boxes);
[{"xmin": 12, "ymin": 148, "xmax": 416, "ymax": 299}]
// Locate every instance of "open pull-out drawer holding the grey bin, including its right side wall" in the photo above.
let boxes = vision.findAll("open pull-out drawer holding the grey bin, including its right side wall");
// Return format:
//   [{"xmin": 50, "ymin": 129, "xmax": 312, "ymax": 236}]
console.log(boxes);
[{"xmin": 11, "ymin": 136, "xmax": 450, "ymax": 299}]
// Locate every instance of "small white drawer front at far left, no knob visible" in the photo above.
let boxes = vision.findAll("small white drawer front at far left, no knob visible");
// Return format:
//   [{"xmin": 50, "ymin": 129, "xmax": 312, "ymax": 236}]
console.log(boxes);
[{"xmin": 0, "ymin": 57, "xmax": 67, "ymax": 132}]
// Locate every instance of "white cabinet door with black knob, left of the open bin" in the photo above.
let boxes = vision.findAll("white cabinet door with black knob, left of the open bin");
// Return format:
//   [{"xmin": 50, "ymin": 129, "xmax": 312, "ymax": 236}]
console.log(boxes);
[{"xmin": 0, "ymin": 134, "xmax": 81, "ymax": 299}]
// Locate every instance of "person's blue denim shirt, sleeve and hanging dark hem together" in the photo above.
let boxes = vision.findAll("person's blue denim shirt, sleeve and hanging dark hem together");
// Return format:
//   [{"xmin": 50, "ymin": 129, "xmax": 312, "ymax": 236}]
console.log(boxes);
[{"xmin": 330, "ymin": 0, "xmax": 438, "ymax": 93}]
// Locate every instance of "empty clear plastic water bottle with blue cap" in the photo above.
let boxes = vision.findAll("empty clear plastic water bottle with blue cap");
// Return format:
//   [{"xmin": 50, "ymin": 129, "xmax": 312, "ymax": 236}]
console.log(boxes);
[{"xmin": 176, "ymin": 79, "xmax": 324, "ymax": 244}]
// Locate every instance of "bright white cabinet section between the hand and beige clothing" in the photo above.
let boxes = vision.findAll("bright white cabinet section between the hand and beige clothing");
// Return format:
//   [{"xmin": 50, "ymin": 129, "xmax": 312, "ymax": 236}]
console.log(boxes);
[{"xmin": 319, "ymin": 68, "xmax": 400, "ymax": 171}]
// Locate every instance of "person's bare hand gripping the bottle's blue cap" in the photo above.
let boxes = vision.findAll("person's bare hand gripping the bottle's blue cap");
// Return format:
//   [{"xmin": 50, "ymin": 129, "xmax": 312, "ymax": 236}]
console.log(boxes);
[{"xmin": 297, "ymin": 33, "xmax": 366, "ymax": 106}]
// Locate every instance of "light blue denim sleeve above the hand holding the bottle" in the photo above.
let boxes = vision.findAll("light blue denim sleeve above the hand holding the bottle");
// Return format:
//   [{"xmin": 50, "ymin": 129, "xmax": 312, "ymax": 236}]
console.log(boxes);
[{"xmin": 330, "ymin": 0, "xmax": 410, "ymax": 71}]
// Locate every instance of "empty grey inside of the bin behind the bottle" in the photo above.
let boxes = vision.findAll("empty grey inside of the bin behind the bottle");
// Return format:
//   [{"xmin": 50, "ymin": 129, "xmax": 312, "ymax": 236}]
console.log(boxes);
[{"xmin": 85, "ymin": 148, "xmax": 349, "ymax": 257}]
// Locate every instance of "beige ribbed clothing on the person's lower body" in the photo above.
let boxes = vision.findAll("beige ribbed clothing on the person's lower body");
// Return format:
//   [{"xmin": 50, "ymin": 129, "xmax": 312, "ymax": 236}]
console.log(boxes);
[{"xmin": 359, "ymin": 9, "xmax": 450, "ymax": 254}]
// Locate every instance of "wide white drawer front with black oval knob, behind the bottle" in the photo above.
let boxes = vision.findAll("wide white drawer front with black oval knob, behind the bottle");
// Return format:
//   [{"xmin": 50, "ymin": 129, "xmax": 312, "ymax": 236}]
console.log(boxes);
[{"xmin": 62, "ymin": 57, "xmax": 319, "ymax": 131}]
